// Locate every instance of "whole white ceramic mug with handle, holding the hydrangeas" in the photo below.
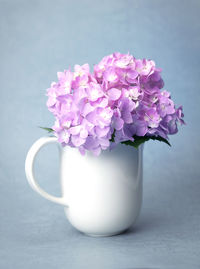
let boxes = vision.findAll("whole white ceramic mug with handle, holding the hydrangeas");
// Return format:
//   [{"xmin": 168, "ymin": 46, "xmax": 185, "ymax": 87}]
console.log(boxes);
[{"xmin": 25, "ymin": 137, "xmax": 143, "ymax": 236}]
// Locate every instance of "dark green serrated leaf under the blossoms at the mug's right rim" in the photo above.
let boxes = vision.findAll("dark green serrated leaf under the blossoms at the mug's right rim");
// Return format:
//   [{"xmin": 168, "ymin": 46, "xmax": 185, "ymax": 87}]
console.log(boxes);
[{"xmin": 121, "ymin": 135, "xmax": 171, "ymax": 148}]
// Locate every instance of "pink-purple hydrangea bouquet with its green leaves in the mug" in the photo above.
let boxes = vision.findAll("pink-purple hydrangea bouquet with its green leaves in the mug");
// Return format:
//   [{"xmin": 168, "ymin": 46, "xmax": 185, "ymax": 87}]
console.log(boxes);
[{"xmin": 44, "ymin": 52, "xmax": 184, "ymax": 155}]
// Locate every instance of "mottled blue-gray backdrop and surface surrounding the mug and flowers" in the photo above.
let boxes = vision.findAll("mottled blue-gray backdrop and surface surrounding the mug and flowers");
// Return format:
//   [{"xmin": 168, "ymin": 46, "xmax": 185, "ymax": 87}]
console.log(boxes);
[{"xmin": 0, "ymin": 0, "xmax": 200, "ymax": 269}]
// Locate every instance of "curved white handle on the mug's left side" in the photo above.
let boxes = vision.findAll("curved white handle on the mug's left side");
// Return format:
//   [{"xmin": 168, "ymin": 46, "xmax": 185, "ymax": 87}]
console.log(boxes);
[{"xmin": 25, "ymin": 136, "xmax": 68, "ymax": 206}]
